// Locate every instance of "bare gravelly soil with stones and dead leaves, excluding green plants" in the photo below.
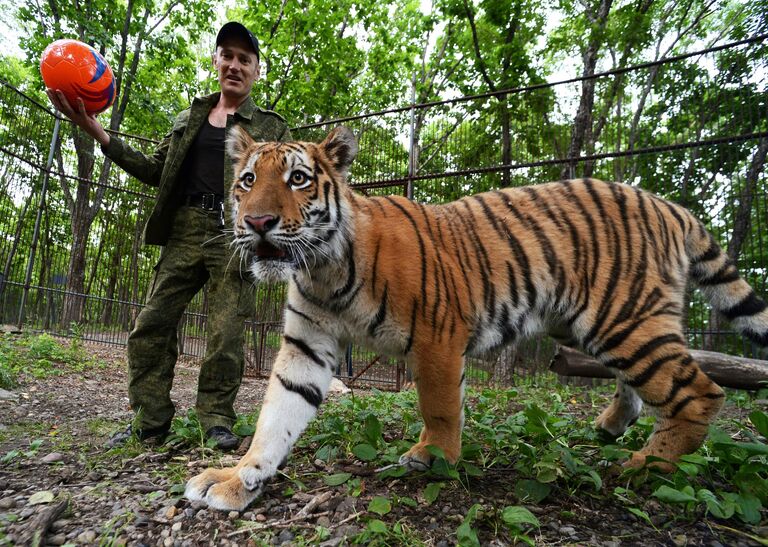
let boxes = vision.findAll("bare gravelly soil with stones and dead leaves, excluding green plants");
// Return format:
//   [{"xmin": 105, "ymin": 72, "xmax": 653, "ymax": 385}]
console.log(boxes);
[{"xmin": 0, "ymin": 340, "xmax": 768, "ymax": 547}]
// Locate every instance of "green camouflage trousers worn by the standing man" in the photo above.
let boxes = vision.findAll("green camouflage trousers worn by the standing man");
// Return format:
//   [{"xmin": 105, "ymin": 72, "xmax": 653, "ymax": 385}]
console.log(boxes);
[{"xmin": 128, "ymin": 207, "xmax": 254, "ymax": 431}]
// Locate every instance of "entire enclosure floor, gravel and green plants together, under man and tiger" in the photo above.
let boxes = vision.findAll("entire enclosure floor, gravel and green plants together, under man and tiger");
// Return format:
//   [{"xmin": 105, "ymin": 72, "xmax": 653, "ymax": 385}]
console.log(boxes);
[{"xmin": 0, "ymin": 336, "xmax": 768, "ymax": 547}]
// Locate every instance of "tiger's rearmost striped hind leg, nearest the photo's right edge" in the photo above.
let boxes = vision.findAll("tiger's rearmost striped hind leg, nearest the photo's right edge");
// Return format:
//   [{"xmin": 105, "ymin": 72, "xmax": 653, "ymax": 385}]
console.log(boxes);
[{"xmin": 597, "ymin": 316, "xmax": 724, "ymax": 471}]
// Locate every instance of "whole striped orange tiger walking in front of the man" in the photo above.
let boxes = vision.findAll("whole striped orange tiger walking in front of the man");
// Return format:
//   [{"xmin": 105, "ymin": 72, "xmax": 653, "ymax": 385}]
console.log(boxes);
[{"xmin": 185, "ymin": 127, "xmax": 768, "ymax": 511}]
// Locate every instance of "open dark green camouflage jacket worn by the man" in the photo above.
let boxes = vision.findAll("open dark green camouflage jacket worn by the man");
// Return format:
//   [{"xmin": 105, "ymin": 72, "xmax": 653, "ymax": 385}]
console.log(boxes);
[{"xmin": 101, "ymin": 93, "xmax": 291, "ymax": 245}]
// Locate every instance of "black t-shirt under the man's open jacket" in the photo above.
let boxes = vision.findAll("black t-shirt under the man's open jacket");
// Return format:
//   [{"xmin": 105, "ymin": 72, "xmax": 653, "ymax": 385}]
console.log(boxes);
[{"xmin": 179, "ymin": 118, "xmax": 226, "ymax": 196}]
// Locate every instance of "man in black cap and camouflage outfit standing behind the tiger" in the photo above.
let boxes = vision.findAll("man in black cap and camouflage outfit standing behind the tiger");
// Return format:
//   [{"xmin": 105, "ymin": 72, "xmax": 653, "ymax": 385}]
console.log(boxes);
[{"xmin": 48, "ymin": 22, "xmax": 290, "ymax": 449}]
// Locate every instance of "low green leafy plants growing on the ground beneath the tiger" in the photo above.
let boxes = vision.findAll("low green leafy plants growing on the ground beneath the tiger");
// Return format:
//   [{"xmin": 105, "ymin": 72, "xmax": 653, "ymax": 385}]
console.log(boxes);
[{"xmin": 297, "ymin": 377, "xmax": 768, "ymax": 545}]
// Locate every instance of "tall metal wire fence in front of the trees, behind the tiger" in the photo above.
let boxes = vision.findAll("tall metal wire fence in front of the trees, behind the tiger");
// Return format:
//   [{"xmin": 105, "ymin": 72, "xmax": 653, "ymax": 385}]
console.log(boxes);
[{"xmin": 0, "ymin": 36, "xmax": 768, "ymax": 389}]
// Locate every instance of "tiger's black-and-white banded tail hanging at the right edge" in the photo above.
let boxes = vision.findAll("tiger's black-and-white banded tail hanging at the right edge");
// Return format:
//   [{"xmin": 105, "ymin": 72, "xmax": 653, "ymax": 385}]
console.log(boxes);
[{"xmin": 685, "ymin": 216, "xmax": 768, "ymax": 349}]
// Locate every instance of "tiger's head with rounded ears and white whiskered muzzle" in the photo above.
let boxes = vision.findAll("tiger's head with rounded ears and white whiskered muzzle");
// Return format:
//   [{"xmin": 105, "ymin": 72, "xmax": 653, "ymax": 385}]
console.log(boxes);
[{"xmin": 227, "ymin": 126, "xmax": 358, "ymax": 281}]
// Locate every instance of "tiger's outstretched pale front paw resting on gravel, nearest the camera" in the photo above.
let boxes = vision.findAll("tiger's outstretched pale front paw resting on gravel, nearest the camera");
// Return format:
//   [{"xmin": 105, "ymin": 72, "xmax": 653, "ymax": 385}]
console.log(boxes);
[{"xmin": 184, "ymin": 465, "xmax": 267, "ymax": 511}]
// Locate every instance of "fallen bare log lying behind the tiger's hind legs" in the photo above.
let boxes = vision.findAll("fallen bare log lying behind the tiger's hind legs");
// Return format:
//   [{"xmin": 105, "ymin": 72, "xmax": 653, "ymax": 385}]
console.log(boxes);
[{"xmin": 549, "ymin": 346, "xmax": 768, "ymax": 390}]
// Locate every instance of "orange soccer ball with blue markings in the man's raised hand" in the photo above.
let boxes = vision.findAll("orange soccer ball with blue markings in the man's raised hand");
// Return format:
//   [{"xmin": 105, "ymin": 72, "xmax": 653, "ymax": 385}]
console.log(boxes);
[{"xmin": 40, "ymin": 40, "xmax": 115, "ymax": 114}]
